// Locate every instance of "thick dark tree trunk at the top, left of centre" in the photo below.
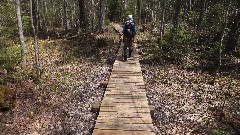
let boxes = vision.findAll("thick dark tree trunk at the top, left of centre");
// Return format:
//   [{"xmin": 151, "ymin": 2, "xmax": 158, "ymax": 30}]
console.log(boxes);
[{"xmin": 79, "ymin": 0, "xmax": 87, "ymax": 32}]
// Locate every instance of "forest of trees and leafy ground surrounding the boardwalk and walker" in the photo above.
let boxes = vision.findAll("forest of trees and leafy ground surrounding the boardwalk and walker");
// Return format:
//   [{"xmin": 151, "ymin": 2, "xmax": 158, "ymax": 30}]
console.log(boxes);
[{"xmin": 0, "ymin": 0, "xmax": 240, "ymax": 135}]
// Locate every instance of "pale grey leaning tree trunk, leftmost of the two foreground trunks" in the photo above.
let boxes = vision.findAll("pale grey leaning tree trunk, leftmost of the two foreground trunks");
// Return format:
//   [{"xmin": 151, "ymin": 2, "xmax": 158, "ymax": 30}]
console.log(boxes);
[{"xmin": 16, "ymin": 0, "xmax": 27, "ymax": 68}]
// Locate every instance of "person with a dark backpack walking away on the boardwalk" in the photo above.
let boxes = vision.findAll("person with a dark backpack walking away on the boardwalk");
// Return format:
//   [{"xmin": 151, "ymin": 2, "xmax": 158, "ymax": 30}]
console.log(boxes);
[{"xmin": 122, "ymin": 15, "xmax": 137, "ymax": 61}]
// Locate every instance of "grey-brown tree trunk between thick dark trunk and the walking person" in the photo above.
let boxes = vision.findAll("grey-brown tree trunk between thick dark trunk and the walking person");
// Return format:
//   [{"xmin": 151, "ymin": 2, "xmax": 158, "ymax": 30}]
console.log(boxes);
[{"xmin": 99, "ymin": 0, "xmax": 106, "ymax": 31}]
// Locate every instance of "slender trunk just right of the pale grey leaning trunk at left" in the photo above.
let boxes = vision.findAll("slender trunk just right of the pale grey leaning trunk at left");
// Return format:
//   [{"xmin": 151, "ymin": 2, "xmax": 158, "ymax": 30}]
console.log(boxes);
[{"xmin": 30, "ymin": 0, "xmax": 40, "ymax": 79}]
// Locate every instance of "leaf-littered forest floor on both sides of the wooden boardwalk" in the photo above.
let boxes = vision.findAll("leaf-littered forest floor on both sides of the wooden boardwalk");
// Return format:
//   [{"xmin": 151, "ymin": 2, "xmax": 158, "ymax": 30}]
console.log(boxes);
[{"xmin": 0, "ymin": 25, "xmax": 240, "ymax": 135}]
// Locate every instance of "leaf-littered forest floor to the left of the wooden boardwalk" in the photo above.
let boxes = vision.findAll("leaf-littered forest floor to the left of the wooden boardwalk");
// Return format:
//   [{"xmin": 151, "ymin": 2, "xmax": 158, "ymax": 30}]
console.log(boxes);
[{"xmin": 0, "ymin": 23, "xmax": 119, "ymax": 135}]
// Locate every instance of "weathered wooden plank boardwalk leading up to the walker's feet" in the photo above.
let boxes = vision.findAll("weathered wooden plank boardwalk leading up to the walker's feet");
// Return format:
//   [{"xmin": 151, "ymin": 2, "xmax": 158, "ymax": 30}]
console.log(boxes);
[{"xmin": 93, "ymin": 42, "xmax": 155, "ymax": 135}]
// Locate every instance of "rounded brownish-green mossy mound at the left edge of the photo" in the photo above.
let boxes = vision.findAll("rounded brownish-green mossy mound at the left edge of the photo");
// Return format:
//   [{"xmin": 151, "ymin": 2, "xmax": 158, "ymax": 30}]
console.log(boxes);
[{"xmin": 0, "ymin": 85, "xmax": 16, "ymax": 111}]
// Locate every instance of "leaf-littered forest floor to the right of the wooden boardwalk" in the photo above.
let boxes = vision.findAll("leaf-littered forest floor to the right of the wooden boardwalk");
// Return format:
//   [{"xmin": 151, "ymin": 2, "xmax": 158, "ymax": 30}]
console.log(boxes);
[{"xmin": 137, "ymin": 34, "xmax": 240, "ymax": 135}]
